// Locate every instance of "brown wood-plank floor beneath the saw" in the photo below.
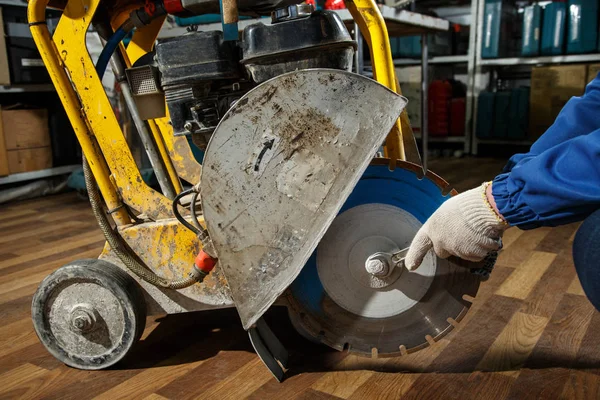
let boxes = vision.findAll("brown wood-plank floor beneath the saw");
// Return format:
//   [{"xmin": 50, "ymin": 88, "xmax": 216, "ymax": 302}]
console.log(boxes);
[{"xmin": 0, "ymin": 160, "xmax": 600, "ymax": 400}]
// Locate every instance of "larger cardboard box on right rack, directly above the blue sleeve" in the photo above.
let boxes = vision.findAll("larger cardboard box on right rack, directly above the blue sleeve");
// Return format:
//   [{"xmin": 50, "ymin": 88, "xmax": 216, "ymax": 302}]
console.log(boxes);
[{"xmin": 529, "ymin": 65, "xmax": 588, "ymax": 140}]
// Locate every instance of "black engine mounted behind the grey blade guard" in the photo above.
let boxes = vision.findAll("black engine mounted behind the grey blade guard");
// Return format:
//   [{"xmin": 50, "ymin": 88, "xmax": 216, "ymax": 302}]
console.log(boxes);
[{"xmin": 155, "ymin": 4, "xmax": 356, "ymax": 150}]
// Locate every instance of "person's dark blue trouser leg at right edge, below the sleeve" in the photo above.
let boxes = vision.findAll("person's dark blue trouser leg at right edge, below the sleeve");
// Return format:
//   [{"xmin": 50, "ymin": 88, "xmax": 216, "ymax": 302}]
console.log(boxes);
[{"xmin": 573, "ymin": 210, "xmax": 600, "ymax": 311}]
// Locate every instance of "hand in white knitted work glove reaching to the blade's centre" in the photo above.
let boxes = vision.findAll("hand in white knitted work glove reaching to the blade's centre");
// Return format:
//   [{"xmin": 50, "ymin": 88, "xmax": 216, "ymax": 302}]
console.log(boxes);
[{"xmin": 404, "ymin": 183, "xmax": 509, "ymax": 271}]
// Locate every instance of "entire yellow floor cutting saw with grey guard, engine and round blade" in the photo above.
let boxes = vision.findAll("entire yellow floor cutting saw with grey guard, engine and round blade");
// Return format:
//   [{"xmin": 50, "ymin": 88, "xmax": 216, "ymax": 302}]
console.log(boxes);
[{"xmin": 28, "ymin": 0, "xmax": 488, "ymax": 380}]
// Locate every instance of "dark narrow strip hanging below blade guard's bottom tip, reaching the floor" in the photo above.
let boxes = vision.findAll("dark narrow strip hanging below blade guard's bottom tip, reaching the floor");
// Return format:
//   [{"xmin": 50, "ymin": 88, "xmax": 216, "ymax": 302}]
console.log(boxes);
[{"xmin": 248, "ymin": 318, "xmax": 289, "ymax": 382}]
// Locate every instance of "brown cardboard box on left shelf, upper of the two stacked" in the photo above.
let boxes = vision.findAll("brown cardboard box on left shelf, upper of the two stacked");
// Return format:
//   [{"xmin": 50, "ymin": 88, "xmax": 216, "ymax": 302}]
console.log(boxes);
[{"xmin": 1, "ymin": 109, "xmax": 50, "ymax": 150}]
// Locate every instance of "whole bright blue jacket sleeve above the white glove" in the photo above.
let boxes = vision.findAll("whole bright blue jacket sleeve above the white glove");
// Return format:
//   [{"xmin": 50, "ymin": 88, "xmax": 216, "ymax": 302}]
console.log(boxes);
[{"xmin": 492, "ymin": 74, "xmax": 600, "ymax": 229}]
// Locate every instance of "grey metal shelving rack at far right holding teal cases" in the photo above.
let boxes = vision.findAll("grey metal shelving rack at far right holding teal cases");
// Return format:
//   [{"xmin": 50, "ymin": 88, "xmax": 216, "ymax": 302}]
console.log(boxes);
[{"xmin": 471, "ymin": 0, "xmax": 600, "ymax": 155}]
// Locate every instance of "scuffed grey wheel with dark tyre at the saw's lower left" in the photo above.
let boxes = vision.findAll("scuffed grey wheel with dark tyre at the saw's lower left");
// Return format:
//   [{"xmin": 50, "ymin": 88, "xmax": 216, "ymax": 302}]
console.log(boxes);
[{"xmin": 31, "ymin": 259, "xmax": 146, "ymax": 370}]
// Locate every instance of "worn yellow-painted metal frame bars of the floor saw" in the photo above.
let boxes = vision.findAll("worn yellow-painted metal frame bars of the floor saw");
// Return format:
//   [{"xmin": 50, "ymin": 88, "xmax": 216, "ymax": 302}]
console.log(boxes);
[{"xmin": 28, "ymin": 0, "xmax": 414, "ymax": 290}]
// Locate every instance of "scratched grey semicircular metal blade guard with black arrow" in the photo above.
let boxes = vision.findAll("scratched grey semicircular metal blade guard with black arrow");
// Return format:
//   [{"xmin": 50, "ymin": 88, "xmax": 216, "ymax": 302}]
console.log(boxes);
[{"xmin": 201, "ymin": 69, "xmax": 407, "ymax": 329}]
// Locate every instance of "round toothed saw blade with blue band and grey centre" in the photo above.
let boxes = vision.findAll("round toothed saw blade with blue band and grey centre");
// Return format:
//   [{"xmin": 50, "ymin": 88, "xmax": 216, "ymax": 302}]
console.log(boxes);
[{"xmin": 287, "ymin": 159, "xmax": 480, "ymax": 356}]
